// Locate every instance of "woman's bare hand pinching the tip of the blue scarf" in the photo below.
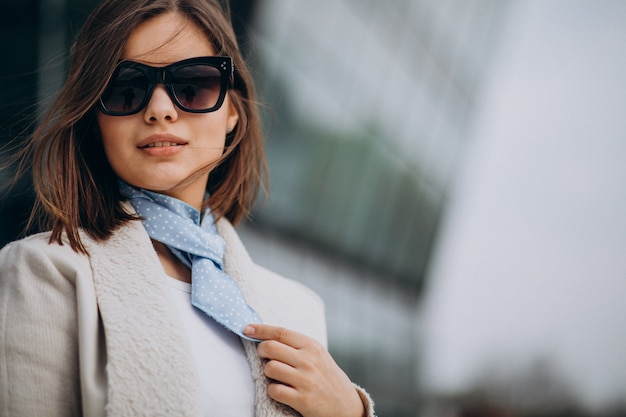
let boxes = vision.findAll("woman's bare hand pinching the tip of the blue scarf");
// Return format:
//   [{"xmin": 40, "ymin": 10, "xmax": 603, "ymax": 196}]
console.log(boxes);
[{"xmin": 244, "ymin": 324, "xmax": 365, "ymax": 417}]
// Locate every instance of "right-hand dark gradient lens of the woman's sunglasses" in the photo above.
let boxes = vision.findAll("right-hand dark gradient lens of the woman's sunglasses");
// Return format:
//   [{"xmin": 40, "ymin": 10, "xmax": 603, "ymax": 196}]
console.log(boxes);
[{"xmin": 172, "ymin": 64, "xmax": 222, "ymax": 111}]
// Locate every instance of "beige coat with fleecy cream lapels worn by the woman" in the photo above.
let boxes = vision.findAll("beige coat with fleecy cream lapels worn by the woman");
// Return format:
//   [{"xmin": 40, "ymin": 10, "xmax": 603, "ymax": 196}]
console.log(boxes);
[{"xmin": 0, "ymin": 216, "xmax": 373, "ymax": 417}]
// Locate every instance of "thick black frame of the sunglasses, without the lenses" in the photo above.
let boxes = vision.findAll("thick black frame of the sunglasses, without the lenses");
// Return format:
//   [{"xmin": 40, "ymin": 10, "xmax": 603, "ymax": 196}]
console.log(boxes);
[{"xmin": 98, "ymin": 56, "xmax": 235, "ymax": 116}]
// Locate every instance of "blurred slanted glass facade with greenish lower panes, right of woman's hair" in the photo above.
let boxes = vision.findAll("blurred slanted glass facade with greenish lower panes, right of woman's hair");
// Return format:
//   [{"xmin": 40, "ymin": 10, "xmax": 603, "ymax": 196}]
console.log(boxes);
[{"xmin": 246, "ymin": 0, "xmax": 505, "ymax": 293}]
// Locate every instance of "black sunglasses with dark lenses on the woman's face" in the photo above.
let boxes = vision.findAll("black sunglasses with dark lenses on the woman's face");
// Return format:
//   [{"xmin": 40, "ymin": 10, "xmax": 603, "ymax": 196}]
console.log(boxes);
[{"xmin": 98, "ymin": 56, "xmax": 233, "ymax": 116}]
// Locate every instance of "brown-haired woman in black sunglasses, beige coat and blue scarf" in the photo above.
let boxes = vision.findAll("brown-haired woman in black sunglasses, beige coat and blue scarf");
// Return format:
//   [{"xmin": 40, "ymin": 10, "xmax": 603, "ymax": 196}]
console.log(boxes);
[{"xmin": 0, "ymin": 0, "xmax": 374, "ymax": 417}]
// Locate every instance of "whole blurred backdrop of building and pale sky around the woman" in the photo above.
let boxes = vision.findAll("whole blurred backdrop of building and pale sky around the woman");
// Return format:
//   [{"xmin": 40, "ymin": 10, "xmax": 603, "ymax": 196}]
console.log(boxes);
[{"xmin": 0, "ymin": 0, "xmax": 626, "ymax": 417}]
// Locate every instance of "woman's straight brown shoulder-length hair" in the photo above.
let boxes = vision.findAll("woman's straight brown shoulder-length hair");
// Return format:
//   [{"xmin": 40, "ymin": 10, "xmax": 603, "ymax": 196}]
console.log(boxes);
[{"xmin": 21, "ymin": 0, "xmax": 267, "ymax": 253}]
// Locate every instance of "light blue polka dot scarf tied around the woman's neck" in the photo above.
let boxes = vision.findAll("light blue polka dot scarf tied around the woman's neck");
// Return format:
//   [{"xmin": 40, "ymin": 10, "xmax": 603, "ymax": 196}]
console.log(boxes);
[{"xmin": 120, "ymin": 181, "xmax": 262, "ymax": 340}]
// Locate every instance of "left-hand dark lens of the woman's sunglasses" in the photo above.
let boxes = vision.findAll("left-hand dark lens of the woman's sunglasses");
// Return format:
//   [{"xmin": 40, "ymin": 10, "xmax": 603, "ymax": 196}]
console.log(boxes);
[{"xmin": 102, "ymin": 67, "xmax": 149, "ymax": 114}]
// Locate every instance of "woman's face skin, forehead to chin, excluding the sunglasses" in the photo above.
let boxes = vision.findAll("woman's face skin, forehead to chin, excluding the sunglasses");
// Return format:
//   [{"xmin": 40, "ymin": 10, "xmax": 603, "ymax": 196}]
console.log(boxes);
[{"xmin": 98, "ymin": 13, "xmax": 238, "ymax": 208}]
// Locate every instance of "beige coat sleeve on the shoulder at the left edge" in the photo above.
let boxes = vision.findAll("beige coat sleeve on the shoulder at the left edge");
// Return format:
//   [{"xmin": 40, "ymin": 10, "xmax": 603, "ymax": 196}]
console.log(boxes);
[{"xmin": 0, "ymin": 239, "xmax": 81, "ymax": 416}]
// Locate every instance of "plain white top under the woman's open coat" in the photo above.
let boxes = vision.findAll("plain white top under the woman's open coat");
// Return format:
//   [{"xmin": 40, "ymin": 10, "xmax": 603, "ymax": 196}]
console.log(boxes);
[{"xmin": 167, "ymin": 277, "xmax": 254, "ymax": 417}]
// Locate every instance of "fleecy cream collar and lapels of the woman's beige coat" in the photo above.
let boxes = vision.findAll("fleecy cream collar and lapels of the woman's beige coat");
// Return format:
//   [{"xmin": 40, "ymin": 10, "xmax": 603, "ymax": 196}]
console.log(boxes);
[{"xmin": 85, "ymin": 213, "xmax": 299, "ymax": 417}]
